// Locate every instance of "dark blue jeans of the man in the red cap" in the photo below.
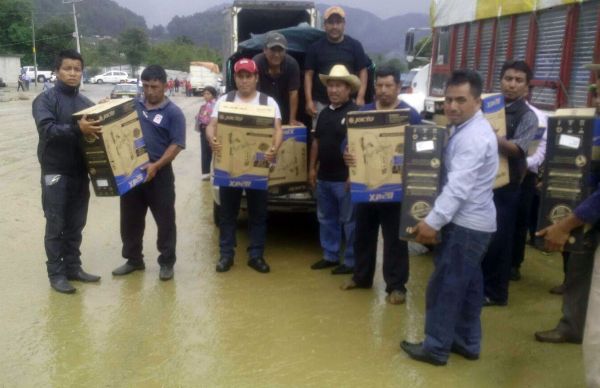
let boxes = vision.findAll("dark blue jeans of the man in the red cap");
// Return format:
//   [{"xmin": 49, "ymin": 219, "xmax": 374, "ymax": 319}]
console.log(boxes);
[{"xmin": 219, "ymin": 187, "xmax": 268, "ymax": 259}]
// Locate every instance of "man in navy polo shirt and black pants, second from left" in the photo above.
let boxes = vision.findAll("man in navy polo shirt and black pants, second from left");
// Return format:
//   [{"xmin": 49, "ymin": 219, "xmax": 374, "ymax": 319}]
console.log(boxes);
[{"xmin": 112, "ymin": 65, "xmax": 185, "ymax": 281}]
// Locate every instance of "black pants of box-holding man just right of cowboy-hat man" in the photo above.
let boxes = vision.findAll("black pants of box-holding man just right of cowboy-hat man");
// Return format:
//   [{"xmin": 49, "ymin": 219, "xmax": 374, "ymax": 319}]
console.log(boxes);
[{"xmin": 352, "ymin": 202, "xmax": 408, "ymax": 293}]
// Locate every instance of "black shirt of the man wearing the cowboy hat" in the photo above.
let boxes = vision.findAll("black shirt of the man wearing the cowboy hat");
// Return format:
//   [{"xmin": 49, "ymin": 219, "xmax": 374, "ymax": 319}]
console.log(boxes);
[{"xmin": 315, "ymin": 101, "xmax": 358, "ymax": 182}]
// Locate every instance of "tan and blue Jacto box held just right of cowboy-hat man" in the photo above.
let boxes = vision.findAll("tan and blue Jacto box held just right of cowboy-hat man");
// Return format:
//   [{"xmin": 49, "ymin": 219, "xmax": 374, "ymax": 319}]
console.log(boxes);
[{"xmin": 347, "ymin": 109, "xmax": 409, "ymax": 203}]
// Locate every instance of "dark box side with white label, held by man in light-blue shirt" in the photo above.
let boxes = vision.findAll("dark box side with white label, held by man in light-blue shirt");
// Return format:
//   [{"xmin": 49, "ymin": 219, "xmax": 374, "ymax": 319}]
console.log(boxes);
[{"xmin": 400, "ymin": 125, "xmax": 448, "ymax": 240}]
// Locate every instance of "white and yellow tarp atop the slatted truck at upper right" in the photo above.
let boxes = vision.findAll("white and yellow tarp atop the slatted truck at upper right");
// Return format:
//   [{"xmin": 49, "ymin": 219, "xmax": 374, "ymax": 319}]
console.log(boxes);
[{"xmin": 430, "ymin": 0, "xmax": 598, "ymax": 27}]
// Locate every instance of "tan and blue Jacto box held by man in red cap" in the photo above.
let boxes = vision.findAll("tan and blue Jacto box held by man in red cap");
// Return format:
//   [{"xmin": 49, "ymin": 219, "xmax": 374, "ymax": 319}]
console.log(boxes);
[{"xmin": 213, "ymin": 101, "xmax": 275, "ymax": 190}]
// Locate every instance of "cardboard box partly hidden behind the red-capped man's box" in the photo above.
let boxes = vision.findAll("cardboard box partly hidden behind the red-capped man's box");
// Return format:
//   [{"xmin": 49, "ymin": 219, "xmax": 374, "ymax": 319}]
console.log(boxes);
[{"xmin": 269, "ymin": 125, "xmax": 308, "ymax": 195}]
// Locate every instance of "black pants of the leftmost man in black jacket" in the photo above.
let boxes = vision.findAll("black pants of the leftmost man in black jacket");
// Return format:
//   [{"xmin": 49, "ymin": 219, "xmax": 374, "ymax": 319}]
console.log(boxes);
[{"xmin": 41, "ymin": 175, "xmax": 90, "ymax": 278}]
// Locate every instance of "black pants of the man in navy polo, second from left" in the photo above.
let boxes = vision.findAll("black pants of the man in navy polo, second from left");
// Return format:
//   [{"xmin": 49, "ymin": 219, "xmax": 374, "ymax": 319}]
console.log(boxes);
[{"xmin": 121, "ymin": 164, "xmax": 177, "ymax": 266}]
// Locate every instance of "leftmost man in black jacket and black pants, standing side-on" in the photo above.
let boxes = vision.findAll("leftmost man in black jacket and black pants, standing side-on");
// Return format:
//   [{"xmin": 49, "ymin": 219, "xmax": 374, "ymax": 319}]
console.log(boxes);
[{"xmin": 33, "ymin": 50, "xmax": 101, "ymax": 294}]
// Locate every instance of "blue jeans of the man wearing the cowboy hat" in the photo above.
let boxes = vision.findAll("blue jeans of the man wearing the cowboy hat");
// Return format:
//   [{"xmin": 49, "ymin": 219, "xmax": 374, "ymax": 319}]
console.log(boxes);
[{"xmin": 317, "ymin": 180, "xmax": 356, "ymax": 267}]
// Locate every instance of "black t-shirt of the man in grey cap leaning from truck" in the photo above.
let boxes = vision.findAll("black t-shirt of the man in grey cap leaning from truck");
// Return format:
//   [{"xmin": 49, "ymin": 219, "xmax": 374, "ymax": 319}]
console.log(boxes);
[{"xmin": 254, "ymin": 53, "xmax": 300, "ymax": 124}]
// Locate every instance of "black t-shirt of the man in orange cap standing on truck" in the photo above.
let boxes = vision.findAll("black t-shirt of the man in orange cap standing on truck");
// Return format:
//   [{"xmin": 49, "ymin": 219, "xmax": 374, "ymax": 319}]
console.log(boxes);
[{"xmin": 304, "ymin": 35, "xmax": 369, "ymax": 104}]
